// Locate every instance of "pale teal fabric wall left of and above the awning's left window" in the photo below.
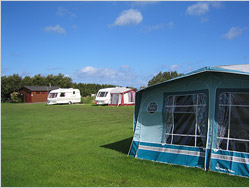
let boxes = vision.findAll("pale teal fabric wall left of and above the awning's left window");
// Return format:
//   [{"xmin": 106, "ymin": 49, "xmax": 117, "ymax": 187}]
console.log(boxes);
[{"xmin": 137, "ymin": 73, "xmax": 211, "ymax": 143}]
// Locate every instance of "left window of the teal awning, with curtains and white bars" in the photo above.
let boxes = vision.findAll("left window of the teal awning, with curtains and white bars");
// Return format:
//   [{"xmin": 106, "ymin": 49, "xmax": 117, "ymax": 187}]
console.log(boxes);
[{"xmin": 163, "ymin": 93, "xmax": 208, "ymax": 147}]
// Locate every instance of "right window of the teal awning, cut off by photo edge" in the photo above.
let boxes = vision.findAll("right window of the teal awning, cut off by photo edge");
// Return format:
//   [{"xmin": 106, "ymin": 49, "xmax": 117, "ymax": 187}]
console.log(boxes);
[{"xmin": 216, "ymin": 92, "xmax": 249, "ymax": 153}]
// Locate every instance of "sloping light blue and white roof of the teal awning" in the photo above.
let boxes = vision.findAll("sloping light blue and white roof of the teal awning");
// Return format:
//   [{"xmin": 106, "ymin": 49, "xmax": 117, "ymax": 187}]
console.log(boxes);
[{"xmin": 138, "ymin": 64, "xmax": 249, "ymax": 92}]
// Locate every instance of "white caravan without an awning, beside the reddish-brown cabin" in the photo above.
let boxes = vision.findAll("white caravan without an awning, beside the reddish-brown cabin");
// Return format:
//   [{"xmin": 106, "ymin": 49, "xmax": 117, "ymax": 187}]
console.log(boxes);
[{"xmin": 47, "ymin": 88, "xmax": 81, "ymax": 105}]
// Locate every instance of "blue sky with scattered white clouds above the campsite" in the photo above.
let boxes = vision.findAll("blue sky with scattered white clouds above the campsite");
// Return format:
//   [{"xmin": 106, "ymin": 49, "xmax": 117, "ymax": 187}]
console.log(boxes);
[{"xmin": 1, "ymin": 1, "xmax": 249, "ymax": 88}]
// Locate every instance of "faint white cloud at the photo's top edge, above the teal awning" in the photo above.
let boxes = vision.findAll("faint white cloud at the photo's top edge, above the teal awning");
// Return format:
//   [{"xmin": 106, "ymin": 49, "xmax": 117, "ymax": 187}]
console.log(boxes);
[{"xmin": 186, "ymin": 2, "xmax": 222, "ymax": 16}]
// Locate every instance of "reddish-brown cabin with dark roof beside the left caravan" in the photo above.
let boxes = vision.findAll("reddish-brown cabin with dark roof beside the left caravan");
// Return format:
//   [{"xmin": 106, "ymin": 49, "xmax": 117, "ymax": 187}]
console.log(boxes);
[{"xmin": 18, "ymin": 86, "xmax": 59, "ymax": 103}]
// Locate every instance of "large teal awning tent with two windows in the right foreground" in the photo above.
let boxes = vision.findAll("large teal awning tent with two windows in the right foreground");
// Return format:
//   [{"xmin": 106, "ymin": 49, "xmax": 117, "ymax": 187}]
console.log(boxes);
[{"xmin": 129, "ymin": 65, "xmax": 249, "ymax": 177}]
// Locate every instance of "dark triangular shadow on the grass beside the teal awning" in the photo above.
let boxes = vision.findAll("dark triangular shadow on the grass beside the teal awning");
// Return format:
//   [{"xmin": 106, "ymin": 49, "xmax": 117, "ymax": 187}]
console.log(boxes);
[{"xmin": 101, "ymin": 137, "xmax": 133, "ymax": 154}]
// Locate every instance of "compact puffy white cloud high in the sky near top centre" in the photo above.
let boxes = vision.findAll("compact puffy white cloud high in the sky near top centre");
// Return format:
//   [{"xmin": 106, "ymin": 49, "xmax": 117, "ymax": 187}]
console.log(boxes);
[{"xmin": 112, "ymin": 9, "xmax": 143, "ymax": 26}]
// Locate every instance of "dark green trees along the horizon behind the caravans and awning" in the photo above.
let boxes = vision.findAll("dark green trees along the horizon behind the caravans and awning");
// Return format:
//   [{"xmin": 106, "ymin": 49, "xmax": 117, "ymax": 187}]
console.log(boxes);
[{"xmin": 1, "ymin": 71, "xmax": 183, "ymax": 102}]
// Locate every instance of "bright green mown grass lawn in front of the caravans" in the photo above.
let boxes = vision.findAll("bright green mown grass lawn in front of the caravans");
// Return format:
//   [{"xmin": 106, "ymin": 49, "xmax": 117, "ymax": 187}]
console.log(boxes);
[{"xmin": 1, "ymin": 104, "xmax": 249, "ymax": 187}]
